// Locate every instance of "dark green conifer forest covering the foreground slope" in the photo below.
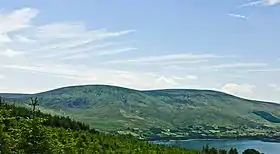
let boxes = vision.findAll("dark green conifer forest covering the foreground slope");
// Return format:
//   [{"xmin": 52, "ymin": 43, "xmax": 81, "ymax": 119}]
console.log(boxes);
[{"xmin": 0, "ymin": 98, "xmax": 259, "ymax": 154}]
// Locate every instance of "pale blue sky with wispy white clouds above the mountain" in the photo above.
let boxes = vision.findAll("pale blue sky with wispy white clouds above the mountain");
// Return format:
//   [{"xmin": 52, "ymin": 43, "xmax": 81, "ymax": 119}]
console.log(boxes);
[{"xmin": 0, "ymin": 0, "xmax": 280, "ymax": 103}]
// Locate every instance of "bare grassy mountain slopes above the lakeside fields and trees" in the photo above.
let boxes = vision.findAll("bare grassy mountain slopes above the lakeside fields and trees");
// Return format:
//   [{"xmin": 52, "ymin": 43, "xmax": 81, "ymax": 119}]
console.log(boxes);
[{"xmin": 1, "ymin": 85, "xmax": 280, "ymax": 130}]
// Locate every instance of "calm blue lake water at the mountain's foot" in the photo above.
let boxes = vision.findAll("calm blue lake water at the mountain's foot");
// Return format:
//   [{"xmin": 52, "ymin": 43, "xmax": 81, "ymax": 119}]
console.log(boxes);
[{"xmin": 154, "ymin": 140, "xmax": 280, "ymax": 154}]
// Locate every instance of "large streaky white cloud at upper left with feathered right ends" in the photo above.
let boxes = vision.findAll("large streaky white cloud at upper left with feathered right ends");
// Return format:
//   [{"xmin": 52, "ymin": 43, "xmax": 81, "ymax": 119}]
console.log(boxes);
[{"xmin": 0, "ymin": 8, "xmax": 135, "ymax": 60}]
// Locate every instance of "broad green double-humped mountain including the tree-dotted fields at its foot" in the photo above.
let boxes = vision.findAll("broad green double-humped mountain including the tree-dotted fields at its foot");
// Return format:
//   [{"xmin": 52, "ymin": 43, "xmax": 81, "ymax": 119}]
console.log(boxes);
[{"xmin": 0, "ymin": 85, "xmax": 280, "ymax": 139}]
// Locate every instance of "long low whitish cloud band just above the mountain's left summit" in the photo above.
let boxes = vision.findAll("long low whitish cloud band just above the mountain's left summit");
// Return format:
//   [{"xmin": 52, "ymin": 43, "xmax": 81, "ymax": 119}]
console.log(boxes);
[{"xmin": 3, "ymin": 64, "xmax": 197, "ymax": 90}]
